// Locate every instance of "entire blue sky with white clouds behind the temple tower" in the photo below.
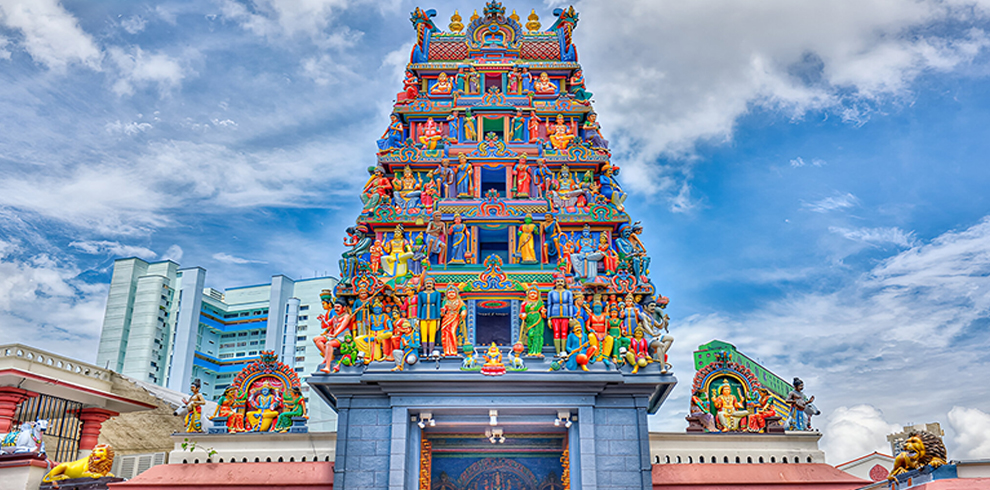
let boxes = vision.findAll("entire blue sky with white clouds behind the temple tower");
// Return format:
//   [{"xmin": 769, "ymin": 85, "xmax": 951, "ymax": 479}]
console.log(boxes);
[{"xmin": 0, "ymin": 0, "xmax": 990, "ymax": 463}]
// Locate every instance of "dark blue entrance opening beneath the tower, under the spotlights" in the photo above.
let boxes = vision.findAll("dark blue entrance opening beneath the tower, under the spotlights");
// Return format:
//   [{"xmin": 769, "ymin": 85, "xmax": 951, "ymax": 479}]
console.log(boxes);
[{"xmin": 421, "ymin": 433, "xmax": 567, "ymax": 490}]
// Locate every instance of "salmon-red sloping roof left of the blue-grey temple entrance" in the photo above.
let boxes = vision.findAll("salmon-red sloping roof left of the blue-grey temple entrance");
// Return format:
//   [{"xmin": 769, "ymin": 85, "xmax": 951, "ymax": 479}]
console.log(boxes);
[{"xmin": 110, "ymin": 461, "xmax": 333, "ymax": 490}]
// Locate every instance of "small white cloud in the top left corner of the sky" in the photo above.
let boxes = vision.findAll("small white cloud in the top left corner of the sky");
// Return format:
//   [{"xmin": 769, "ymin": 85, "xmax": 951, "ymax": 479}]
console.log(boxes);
[{"xmin": 0, "ymin": 0, "xmax": 101, "ymax": 70}]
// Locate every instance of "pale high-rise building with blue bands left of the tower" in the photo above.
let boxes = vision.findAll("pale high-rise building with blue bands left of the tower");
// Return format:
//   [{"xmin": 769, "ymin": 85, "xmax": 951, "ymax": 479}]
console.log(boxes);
[{"xmin": 96, "ymin": 258, "xmax": 337, "ymax": 430}]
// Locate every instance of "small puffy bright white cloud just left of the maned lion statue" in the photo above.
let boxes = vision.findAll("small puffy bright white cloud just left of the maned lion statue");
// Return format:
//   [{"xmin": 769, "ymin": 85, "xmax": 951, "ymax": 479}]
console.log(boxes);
[{"xmin": 819, "ymin": 405, "xmax": 901, "ymax": 464}]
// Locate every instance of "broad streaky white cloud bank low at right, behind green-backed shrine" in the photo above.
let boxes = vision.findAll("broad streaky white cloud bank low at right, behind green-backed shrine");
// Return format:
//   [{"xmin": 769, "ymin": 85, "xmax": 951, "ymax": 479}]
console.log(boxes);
[{"xmin": 654, "ymin": 217, "xmax": 990, "ymax": 463}]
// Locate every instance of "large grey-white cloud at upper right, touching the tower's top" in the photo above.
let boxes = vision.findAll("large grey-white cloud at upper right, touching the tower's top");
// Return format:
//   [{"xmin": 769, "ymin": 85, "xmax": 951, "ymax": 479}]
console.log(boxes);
[{"xmin": 572, "ymin": 0, "xmax": 990, "ymax": 206}]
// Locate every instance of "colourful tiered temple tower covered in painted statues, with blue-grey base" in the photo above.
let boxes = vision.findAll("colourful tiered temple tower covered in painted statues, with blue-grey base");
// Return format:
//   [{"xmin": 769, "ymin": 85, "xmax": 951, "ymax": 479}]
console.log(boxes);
[{"xmin": 307, "ymin": 2, "xmax": 676, "ymax": 490}]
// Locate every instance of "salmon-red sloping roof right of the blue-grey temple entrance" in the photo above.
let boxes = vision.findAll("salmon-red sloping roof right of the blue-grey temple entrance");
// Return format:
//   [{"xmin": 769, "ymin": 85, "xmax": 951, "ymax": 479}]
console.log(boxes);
[{"xmin": 653, "ymin": 463, "xmax": 872, "ymax": 490}]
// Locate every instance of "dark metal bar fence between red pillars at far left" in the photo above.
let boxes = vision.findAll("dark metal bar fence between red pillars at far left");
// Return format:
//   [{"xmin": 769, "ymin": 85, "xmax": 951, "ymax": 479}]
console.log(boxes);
[{"xmin": 14, "ymin": 395, "xmax": 83, "ymax": 462}]
